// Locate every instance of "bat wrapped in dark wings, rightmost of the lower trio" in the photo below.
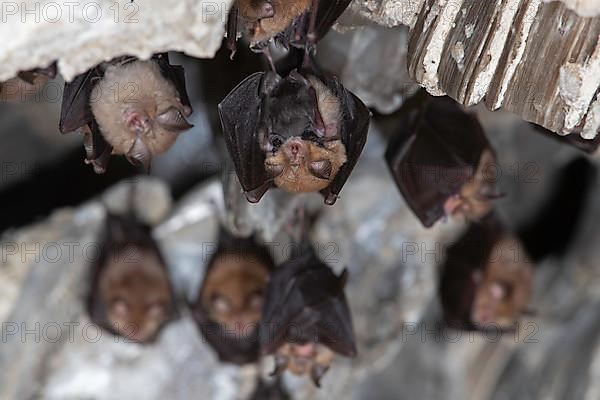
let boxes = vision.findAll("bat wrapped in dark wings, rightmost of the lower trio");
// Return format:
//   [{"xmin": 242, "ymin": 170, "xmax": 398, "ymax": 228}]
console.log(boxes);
[{"xmin": 260, "ymin": 241, "xmax": 356, "ymax": 387}]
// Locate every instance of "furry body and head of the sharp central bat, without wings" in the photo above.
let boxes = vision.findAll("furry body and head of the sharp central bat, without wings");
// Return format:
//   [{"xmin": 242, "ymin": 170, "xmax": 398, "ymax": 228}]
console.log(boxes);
[{"xmin": 262, "ymin": 71, "xmax": 347, "ymax": 193}]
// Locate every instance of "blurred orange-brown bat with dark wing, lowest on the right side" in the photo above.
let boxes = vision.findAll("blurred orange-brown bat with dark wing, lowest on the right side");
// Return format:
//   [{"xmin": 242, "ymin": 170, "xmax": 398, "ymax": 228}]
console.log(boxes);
[{"xmin": 440, "ymin": 216, "xmax": 533, "ymax": 330}]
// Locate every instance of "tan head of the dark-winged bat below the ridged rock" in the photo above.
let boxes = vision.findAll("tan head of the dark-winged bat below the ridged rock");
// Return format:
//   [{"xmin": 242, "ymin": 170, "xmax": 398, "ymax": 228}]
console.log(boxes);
[{"xmin": 444, "ymin": 148, "xmax": 498, "ymax": 221}]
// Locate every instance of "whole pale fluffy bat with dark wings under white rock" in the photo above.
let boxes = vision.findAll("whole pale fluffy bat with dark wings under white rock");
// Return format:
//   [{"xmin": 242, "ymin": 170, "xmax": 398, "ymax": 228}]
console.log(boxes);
[{"xmin": 59, "ymin": 53, "xmax": 192, "ymax": 173}]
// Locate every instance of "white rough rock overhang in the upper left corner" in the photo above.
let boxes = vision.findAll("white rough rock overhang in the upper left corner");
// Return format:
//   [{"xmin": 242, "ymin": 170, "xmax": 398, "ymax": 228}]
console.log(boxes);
[{"xmin": 0, "ymin": 0, "xmax": 232, "ymax": 81}]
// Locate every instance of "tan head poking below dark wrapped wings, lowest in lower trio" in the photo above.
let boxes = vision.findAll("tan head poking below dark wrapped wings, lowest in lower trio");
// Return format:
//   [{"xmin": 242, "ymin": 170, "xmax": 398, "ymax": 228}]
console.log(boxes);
[{"xmin": 274, "ymin": 342, "xmax": 335, "ymax": 387}]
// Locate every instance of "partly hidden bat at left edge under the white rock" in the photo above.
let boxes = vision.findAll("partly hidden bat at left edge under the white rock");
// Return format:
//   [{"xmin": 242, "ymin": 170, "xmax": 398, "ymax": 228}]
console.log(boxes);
[{"xmin": 0, "ymin": 63, "xmax": 56, "ymax": 101}]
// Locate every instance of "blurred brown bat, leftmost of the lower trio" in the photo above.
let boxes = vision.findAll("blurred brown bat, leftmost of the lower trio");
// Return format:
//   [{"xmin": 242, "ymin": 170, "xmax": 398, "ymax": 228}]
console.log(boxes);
[{"xmin": 88, "ymin": 214, "xmax": 176, "ymax": 343}]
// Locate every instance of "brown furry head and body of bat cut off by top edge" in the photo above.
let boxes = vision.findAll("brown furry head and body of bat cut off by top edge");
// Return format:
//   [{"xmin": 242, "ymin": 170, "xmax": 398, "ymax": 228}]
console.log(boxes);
[{"xmin": 238, "ymin": 0, "xmax": 311, "ymax": 43}]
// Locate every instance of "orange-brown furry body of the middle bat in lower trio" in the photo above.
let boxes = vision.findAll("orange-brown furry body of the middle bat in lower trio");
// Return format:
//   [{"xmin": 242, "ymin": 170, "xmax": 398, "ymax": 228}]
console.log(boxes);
[{"xmin": 201, "ymin": 252, "xmax": 269, "ymax": 337}]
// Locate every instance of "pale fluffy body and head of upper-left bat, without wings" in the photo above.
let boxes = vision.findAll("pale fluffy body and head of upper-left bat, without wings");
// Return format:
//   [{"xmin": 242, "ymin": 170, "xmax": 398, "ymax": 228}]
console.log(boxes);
[{"xmin": 91, "ymin": 61, "xmax": 192, "ymax": 164}]
